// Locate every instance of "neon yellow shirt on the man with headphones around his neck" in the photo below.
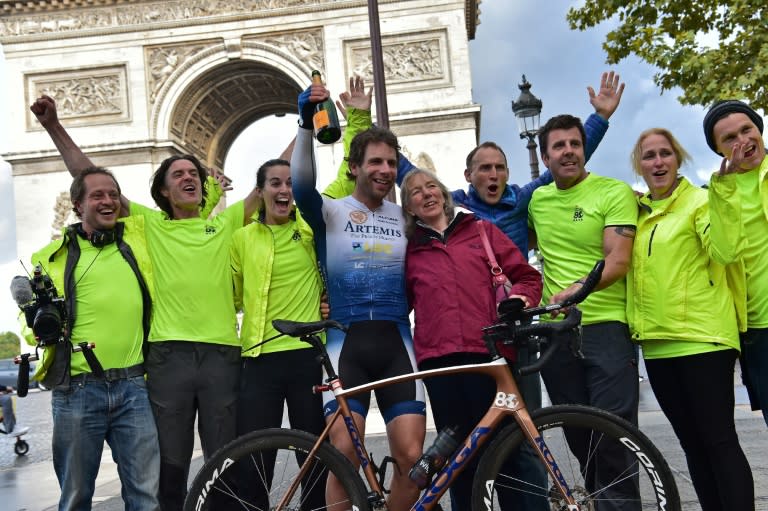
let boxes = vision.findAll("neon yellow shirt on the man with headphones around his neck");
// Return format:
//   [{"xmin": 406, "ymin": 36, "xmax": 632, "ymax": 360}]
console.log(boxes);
[{"xmin": 70, "ymin": 236, "xmax": 144, "ymax": 376}]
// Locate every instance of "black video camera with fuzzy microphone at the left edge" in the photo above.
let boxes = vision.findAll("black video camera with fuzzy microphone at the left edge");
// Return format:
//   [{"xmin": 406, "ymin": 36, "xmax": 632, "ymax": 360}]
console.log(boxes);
[{"xmin": 11, "ymin": 265, "xmax": 67, "ymax": 347}]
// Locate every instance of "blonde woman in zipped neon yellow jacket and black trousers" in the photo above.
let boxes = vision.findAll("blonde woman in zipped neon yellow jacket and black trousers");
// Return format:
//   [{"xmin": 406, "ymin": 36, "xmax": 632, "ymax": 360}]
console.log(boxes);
[{"xmin": 627, "ymin": 128, "xmax": 754, "ymax": 511}]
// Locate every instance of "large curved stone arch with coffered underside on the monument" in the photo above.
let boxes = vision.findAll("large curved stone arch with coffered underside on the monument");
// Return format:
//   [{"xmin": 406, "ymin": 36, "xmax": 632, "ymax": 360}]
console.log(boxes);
[{"xmin": 150, "ymin": 41, "xmax": 310, "ymax": 168}]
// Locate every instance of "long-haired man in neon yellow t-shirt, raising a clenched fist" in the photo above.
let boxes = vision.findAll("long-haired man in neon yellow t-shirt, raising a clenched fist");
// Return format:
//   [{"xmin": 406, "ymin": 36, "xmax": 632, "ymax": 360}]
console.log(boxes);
[{"xmin": 30, "ymin": 96, "xmax": 258, "ymax": 511}]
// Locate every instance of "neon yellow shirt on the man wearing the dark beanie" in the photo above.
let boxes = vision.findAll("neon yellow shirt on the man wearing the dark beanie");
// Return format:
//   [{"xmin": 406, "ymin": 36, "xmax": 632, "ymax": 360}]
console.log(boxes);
[{"xmin": 736, "ymin": 168, "xmax": 768, "ymax": 328}]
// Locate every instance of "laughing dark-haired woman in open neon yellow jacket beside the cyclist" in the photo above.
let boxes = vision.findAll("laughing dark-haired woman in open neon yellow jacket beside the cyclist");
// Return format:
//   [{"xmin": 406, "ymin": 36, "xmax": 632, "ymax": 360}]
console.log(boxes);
[{"xmin": 230, "ymin": 159, "xmax": 325, "ymax": 509}]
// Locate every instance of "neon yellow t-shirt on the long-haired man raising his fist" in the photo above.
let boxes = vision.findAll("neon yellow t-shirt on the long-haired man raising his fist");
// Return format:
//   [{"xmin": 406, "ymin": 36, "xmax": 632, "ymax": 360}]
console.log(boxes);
[{"xmin": 131, "ymin": 201, "xmax": 245, "ymax": 346}]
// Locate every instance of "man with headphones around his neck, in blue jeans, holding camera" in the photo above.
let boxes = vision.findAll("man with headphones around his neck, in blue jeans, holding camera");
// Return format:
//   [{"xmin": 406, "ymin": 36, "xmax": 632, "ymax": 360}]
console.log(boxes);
[{"xmin": 28, "ymin": 167, "xmax": 160, "ymax": 511}]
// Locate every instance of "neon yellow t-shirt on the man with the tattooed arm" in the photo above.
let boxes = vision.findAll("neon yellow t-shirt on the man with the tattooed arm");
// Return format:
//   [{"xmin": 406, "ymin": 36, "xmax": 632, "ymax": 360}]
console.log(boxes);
[{"xmin": 528, "ymin": 174, "xmax": 637, "ymax": 325}]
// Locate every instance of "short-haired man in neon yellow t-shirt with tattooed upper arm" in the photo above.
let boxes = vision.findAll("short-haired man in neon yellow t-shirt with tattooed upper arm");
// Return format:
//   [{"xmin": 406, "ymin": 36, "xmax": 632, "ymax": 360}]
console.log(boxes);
[{"xmin": 528, "ymin": 115, "xmax": 638, "ymax": 509}]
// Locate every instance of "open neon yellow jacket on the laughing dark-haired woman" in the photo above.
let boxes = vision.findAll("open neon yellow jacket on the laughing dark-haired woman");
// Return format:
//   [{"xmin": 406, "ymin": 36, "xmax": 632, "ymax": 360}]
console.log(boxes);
[{"xmin": 230, "ymin": 210, "xmax": 323, "ymax": 357}]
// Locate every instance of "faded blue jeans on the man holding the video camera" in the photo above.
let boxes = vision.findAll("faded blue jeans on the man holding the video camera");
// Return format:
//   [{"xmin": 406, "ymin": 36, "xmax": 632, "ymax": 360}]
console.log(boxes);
[{"xmin": 51, "ymin": 376, "xmax": 160, "ymax": 511}]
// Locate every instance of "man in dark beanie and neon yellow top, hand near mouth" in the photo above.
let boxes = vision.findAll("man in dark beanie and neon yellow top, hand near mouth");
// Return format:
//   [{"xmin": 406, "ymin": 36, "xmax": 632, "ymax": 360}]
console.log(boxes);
[{"xmin": 704, "ymin": 100, "xmax": 768, "ymax": 424}]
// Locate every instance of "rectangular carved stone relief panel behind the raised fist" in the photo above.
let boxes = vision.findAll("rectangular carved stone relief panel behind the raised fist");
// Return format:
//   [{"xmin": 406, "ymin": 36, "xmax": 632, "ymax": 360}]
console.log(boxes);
[{"xmin": 24, "ymin": 65, "xmax": 130, "ymax": 129}]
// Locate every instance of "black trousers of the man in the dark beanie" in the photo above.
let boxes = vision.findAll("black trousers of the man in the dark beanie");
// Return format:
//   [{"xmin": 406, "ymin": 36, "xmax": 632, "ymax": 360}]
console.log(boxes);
[{"xmin": 741, "ymin": 328, "xmax": 768, "ymax": 425}]
